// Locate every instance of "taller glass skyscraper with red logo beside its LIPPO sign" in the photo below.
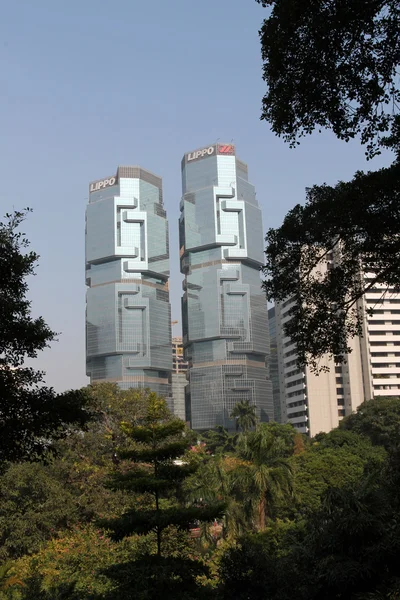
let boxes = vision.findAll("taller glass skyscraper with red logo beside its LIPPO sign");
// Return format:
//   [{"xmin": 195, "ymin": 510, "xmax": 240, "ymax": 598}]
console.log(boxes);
[{"xmin": 179, "ymin": 144, "xmax": 273, "ymax": 429}]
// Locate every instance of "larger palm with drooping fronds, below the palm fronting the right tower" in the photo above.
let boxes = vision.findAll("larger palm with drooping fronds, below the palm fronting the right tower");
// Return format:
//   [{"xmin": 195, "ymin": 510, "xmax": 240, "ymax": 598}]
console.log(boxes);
[{"xmin": 234, "ymin": 423, "xmax": 293, "ymax": 531}]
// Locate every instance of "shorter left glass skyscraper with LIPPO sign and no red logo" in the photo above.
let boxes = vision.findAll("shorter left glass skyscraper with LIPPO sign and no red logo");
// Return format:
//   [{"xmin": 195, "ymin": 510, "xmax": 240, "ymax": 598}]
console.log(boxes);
[{"xmin": 86, "ymin": 167, "xmax": 172, "ymax": 399}]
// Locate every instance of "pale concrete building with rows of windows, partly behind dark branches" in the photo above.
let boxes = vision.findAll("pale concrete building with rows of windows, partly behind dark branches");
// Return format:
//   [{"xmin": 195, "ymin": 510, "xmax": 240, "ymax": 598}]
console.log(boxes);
[{"xmin": 269, "ymin": 275, "xmax": 400, "ymax": 437}]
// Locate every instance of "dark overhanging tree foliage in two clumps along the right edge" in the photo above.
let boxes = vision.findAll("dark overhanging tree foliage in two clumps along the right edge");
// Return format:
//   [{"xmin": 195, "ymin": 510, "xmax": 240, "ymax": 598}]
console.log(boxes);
[{"xmin": 257, "ymin": 0, "xmax": 400, "ymax": 370}]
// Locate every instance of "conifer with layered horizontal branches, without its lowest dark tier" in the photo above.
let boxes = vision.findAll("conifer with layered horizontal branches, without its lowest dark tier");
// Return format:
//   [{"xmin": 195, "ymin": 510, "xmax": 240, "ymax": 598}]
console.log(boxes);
[{"xmin": 106, "ymin": 392, "xmax": 221, "ymax": 544}]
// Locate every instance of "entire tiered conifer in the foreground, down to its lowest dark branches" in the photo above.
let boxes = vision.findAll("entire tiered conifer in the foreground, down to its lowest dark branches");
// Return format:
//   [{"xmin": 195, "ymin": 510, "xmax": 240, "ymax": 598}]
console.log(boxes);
[{"xmin": 100, "ymin": 392, "xmax": 223, "ymax": 600}]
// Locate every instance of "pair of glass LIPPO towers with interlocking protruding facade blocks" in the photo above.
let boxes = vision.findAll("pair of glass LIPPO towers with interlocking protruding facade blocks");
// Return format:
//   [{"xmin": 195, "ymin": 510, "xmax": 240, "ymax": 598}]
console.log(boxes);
[{"xmin": 86, "ymin": 144, "xmax": 273, "ymax": 430}]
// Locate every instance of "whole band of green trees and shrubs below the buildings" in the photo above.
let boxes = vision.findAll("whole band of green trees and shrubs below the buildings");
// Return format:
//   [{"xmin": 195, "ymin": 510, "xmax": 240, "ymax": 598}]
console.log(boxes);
[{"xmin": 0, "ymin": 384, "xmax": 400, "ymax": 600}]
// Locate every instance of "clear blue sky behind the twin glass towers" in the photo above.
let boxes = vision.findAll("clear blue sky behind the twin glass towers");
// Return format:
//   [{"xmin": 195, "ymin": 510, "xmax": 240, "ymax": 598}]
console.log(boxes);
[{"xmin": 0, "ymin": 0, "xmax": 388, "ymax": 391}]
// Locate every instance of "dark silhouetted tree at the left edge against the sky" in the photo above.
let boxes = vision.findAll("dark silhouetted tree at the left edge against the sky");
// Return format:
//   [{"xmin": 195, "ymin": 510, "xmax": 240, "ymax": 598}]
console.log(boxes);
[{"xmin": 0, "ymin": 211, "xmax": 91, "ymax": 465}]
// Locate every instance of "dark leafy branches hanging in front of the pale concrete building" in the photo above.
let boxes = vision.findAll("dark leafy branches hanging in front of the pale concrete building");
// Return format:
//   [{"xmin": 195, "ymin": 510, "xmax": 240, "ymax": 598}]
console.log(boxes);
[{"xmin": 263, "ymin": 162, "xmax": 400, "ymax": 370}]
